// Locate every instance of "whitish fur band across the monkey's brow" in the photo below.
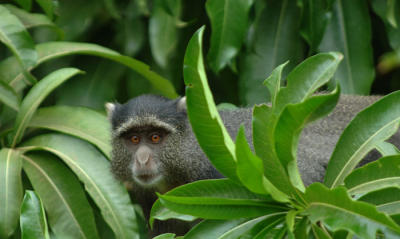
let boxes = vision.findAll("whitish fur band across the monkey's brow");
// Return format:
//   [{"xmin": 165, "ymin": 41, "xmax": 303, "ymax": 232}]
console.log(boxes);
[{"xmin": 114, "ymin": 115, "xmax": 176, "ymax": 137}]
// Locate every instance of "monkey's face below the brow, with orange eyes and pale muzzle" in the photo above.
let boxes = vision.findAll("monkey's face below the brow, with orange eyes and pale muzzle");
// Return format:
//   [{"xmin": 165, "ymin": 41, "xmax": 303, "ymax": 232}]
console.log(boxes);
[{"xmin": 123, "ymin": 128, "xmax": 169, "ymax": 187}]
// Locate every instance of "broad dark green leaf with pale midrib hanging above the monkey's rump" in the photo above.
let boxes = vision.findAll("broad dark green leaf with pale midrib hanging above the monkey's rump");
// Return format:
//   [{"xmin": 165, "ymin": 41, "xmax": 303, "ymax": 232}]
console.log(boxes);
[{"xmin": 320, "ymin": 0, "xmax": 375, "ymax": 95}]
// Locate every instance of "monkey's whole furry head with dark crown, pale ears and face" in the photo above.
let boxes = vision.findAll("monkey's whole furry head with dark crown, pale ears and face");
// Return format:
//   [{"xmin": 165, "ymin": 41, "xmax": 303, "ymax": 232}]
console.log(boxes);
[{"xmin": 106, "ymin": 95, "xmax": 187, "ymax": 189}]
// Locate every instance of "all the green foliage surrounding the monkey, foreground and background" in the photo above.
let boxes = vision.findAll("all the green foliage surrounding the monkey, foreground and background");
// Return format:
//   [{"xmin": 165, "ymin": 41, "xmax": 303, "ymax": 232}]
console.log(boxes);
[{"xmin": 0, "ymin": 0, "xmax": 400, "ymax": 238}]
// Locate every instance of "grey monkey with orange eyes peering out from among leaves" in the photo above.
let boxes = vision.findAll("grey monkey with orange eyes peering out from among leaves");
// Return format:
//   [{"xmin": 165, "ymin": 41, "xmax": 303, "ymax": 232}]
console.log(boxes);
[{"xmin": 106, "ymin": 95, "xmax": 400, "ymax": 236}]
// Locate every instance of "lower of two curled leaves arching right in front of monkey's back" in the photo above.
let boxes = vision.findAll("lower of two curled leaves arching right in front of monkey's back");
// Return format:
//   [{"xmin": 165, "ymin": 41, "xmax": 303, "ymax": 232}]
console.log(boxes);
[{"xmin": 274, "ymin": 88, "xmax": 340, "ymax": 192}]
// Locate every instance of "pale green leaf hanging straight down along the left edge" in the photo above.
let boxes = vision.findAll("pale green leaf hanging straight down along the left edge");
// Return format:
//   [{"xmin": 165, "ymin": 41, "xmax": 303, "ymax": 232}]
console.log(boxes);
[{"xmin": 0, "ymin": 148, "xmax": 23, "ymax": 238}]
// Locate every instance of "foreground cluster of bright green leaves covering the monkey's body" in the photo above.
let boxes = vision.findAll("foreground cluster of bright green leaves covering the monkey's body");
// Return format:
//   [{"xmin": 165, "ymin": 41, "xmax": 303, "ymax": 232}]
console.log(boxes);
[{"xmin": 151, "ymin": 28, "xmax": 400, "ymax": 239}]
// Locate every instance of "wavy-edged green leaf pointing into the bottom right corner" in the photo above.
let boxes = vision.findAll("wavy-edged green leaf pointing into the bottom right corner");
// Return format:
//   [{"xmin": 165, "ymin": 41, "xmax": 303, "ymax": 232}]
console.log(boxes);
[{"xmin": 304, "ymin": 183, "xmax": 400, "ymax": 239}]
